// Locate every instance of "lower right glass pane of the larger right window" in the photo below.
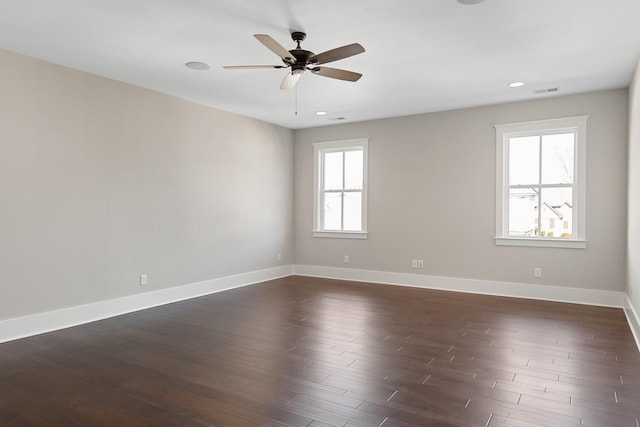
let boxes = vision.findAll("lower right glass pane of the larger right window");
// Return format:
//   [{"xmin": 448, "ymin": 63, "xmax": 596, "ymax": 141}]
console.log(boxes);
[{"xmin": 540, "ymin": 187, "xmax": 573, "ymax": 239}]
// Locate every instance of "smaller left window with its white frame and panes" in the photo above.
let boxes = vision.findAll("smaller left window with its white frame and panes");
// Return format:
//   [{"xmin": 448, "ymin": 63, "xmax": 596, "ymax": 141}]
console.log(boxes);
[{"xmin": 313, "ymin": 139, "xmax": 368, "ymax": 239}]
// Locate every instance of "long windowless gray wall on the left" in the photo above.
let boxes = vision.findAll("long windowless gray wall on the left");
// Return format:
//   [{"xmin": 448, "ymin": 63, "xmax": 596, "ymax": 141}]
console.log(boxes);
[{"xmin": 0, "ymin": 51, "xmax": 293, "ymax": 320}]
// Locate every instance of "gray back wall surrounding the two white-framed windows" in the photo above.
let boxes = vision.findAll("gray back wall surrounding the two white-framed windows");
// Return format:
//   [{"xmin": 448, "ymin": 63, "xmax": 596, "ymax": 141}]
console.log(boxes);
[{"xmin": 294, "ymin": 90, "xmax": 628, "ymax": 291}]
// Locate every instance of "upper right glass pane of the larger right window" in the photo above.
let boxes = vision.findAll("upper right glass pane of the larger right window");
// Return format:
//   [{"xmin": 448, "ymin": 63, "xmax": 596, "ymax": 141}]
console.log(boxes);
[{"xmin": 542, "ymin": 133, "xmax": 574, "ymax": 184}]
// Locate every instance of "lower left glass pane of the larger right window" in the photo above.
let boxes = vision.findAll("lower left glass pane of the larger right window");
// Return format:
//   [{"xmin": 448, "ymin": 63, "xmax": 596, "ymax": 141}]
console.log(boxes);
[{"xmin": 509, "ymin": 188, "xmax": 538, "ymax": 237}]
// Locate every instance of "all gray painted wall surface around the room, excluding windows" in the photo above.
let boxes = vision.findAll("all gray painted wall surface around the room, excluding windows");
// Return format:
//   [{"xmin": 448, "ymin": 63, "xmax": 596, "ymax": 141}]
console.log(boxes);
[{"xmin": 0, "ymin": 43, "xmax": 640, "ymax": 320}]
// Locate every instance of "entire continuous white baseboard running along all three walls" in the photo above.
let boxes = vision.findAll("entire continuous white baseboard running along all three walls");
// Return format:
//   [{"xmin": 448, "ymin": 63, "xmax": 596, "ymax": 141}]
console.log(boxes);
[{"xmin": 0, "ymin": 265, "xmax": 640, "ymax": 348}]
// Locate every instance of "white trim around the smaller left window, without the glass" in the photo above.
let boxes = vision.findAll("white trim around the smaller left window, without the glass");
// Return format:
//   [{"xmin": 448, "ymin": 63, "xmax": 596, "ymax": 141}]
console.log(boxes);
[{"xmin": 312, "ymin": 138, "xmax": 369, "ymax": 239}]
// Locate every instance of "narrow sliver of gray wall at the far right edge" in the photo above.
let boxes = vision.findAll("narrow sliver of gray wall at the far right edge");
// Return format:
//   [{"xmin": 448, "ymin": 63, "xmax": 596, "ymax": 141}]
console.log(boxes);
[{"xmin": 627, "ymin": 62, "xmax": 640, "ymax": 314}]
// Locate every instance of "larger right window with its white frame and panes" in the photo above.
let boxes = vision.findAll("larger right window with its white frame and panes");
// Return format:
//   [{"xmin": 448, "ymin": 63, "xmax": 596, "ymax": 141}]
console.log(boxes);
[{"xmin": 496, "ymin": 116, "xmax": 587, "ymax": 248}]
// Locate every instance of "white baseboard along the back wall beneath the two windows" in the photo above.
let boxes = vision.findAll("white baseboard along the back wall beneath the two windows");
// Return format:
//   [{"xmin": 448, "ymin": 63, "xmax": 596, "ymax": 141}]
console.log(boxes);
[{"xmin": 293, "ymin": 265, "xmax": 626, "ymax": 308}]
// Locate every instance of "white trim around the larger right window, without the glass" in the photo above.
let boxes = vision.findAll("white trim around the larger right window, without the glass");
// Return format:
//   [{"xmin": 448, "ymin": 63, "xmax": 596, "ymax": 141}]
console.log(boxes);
[{"xmin": 495, "ymin": 116, "xmax": 589, "ymax": 249}]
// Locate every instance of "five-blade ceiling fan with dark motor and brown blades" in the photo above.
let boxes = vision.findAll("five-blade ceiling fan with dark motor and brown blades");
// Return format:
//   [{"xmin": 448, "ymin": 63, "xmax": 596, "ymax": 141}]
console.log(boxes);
[{"xmin": 223, "ymin": 31, "xmax": 364, "ymax": 89}]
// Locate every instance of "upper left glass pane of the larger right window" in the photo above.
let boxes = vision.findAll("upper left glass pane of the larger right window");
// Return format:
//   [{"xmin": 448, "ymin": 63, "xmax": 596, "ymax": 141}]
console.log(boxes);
[{"xmin": 509, "ymin": 136, "xmax": 540, "ymax": 185}]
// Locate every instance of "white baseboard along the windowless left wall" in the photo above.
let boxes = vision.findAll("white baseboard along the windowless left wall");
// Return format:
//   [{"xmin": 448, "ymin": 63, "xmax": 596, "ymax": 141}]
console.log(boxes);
[{"xmin": 0, "ymin": 265, "xmax": 292, "ymax": 343}]
